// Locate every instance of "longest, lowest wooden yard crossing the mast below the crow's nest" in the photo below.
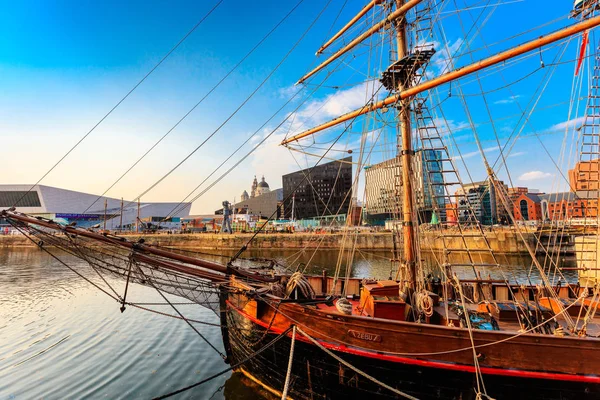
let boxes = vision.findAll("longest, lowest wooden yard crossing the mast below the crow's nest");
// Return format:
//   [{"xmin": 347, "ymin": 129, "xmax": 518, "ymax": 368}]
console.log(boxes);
[{"xmin": 281, "ymin": 15, "xmax": 600, "ymax": 145}]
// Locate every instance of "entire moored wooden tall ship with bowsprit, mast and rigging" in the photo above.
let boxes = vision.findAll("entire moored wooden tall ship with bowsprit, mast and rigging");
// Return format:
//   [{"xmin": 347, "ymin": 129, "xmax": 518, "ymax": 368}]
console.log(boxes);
[{"xmin": 2, "ymin": 0, "xmax": 600, "ymax": 399}]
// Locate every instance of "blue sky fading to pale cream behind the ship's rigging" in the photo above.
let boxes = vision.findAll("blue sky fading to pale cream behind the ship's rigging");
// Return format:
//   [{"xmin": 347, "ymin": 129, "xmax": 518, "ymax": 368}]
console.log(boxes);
[{"xmin": 0, "ymin": 0, "xmax": 594, "ymax": 213}]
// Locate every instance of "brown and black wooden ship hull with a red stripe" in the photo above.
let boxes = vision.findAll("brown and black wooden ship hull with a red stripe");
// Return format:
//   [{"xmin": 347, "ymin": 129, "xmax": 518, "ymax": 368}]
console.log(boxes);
[{"xmin": 221, "ymin": 276, "xmax": 600, "ymax": 399}]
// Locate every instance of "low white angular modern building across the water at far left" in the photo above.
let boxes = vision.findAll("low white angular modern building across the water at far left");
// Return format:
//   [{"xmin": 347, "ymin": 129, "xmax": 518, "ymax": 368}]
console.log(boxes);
[{"xmin": 0, "ymin": 185, "xmax": 192, "ymax": 230}]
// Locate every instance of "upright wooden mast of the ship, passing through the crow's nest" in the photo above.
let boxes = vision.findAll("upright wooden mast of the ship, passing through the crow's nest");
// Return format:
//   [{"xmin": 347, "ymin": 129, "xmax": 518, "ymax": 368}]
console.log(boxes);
[{"xmin": 395, "ymin": 0, "xmax": 417, "ymax": 289}]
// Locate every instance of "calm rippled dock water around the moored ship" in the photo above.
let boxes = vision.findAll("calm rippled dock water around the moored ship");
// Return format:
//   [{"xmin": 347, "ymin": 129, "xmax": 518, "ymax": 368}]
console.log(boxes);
[{"xmin": 0, "ymin": 245, "xmax": 574, "ymax": 400}]
